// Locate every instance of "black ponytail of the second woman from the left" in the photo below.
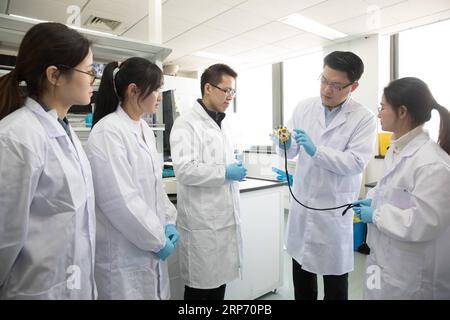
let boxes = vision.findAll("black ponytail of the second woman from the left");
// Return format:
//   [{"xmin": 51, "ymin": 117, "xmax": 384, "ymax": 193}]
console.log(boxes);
[{"xmin": 92, "ymin": 61, "xmax": 120, "ymax": 127}]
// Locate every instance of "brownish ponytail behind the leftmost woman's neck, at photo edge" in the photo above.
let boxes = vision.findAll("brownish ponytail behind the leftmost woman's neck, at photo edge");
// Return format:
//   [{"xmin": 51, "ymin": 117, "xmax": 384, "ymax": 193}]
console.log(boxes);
[{"xmin": 0, "ymin": 69, "xmax": 25, "ymax": 120}]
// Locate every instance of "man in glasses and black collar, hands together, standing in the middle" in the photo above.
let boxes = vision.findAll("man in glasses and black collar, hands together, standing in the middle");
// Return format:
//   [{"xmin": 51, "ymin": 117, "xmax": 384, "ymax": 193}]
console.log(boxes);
[{"xmin": 170, "ymin": 64, "xmax": 247, "ymax": 300}]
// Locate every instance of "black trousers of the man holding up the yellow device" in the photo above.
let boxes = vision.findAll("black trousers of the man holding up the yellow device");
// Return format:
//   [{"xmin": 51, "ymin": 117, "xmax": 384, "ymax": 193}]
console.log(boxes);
[{"xmin": 292, "ymin": 259, "xmax": 348, "ymax": 300}]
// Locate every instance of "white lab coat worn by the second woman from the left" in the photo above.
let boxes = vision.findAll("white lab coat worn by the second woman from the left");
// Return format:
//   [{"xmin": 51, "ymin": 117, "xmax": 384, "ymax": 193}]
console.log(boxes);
[{"xmin": 86, "ymin": 106, "xmax": 176, "ymax": 299}]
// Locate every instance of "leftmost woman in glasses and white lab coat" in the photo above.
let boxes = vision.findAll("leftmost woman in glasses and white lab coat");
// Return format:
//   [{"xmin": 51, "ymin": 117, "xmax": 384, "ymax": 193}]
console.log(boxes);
[{"xmin": 0, "ymin": 23, "xmax": 96, "ymax": 299}]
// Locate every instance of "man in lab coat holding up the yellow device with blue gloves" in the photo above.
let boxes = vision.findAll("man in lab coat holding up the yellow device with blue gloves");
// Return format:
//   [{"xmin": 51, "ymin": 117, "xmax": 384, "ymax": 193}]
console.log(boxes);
[{"xmin": 277, "ymin": 51, "xmax": 376, "ymax": 299}]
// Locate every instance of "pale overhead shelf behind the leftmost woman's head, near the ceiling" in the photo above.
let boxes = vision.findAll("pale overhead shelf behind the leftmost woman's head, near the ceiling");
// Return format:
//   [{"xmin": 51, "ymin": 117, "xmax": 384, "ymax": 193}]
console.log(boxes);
[{"xmin": 0, "ymin": 14, "xmax": 172, "ymax": 62}]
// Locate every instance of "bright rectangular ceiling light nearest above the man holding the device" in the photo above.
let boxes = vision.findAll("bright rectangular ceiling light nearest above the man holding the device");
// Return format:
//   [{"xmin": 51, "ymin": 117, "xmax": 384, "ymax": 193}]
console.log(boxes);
[{"xmin": 278, "ymin": 13, "xmax": 348, "ymax": 40}]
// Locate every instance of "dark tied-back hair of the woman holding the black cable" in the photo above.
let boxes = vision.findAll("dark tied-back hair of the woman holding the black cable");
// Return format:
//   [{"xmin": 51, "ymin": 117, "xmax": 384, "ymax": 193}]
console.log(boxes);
[{"xmin": 384, "ymin": 77, "xmax": 450, "ymax": 154}]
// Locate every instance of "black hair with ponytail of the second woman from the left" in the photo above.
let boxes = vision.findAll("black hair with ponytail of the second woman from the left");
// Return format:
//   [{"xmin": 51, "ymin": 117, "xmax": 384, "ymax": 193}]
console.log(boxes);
[{"xmin": 92, "ymin": 57, "xmax": 163, "ymax": 126}]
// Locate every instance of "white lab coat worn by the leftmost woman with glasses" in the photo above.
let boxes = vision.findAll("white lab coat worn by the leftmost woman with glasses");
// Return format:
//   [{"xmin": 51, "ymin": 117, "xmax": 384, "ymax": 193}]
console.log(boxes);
[{"xmin": 0, "ymin": 98, "xmax": 96, "ymax": 299}]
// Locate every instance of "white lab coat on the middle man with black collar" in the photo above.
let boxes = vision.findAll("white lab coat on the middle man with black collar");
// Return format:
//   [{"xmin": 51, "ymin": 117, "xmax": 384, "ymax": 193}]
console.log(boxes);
[{"xmin": 170, "ymin": 102, "xmax": 242, "ymax": 289}]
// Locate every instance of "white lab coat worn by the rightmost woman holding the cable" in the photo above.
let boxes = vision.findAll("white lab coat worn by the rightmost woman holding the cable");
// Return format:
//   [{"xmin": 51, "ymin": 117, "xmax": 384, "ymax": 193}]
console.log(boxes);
[{"xmin": 364, "ymin": 132, "xmax": 450, "ymax": 299}]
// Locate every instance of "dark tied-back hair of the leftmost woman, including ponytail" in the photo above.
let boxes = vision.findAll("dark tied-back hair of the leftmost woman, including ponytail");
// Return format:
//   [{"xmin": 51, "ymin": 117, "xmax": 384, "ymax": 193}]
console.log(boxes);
[{"xmin": 0, "ymin": 22, "xmax": 91, "ymax": 119}]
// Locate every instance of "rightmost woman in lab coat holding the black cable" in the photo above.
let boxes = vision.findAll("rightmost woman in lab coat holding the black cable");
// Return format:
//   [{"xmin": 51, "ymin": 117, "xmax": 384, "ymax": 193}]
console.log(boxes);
[{"xmin": 354, "ymin": 78, "xmax": 450, "ymax": 299}]
